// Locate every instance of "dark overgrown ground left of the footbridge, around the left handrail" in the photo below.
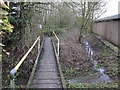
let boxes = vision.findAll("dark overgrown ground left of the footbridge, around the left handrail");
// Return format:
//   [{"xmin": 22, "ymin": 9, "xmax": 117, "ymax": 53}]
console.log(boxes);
[{"xmin": 2, "ymin": 38, "xmax": 37, "ymax": 88}]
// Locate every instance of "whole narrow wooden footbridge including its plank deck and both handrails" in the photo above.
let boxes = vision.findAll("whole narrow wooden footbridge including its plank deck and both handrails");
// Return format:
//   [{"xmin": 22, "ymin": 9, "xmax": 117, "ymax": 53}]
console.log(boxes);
[{"xmin": 10, "ymin": 31, "xmax": 66, "ymax": 88}]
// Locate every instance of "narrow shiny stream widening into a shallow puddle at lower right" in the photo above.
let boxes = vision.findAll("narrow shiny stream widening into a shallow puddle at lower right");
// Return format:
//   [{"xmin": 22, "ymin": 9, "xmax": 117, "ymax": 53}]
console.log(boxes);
[{"xmin": 69, "ymin": 36, "xmax": 112, "ymax": 84}]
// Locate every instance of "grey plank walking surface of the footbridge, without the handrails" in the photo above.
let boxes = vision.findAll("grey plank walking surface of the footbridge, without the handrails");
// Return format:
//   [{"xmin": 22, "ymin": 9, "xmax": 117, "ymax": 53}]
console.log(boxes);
[{"xmin": 32, "ymin": 38, "xmax": 62, "ymax": 88}]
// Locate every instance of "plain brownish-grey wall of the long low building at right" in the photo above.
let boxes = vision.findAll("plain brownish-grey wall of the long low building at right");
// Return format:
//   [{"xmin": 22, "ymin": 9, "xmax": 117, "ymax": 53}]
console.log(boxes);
[{"xmin": 93, "ymin": 20, "xmax": 120, "ymax": 46}]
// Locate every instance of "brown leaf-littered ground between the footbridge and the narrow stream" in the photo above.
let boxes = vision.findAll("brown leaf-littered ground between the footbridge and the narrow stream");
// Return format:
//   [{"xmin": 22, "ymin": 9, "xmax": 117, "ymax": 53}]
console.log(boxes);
[{"xmin": 59, "ymin": 28, "xmax": 92, "ymax": 78}]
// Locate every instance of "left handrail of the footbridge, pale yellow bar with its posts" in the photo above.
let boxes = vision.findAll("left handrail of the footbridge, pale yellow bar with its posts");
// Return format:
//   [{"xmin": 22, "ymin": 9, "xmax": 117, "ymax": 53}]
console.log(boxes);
[{"xmin": 10, "ymin": 36, "xmax": 40, "ymax": 88}]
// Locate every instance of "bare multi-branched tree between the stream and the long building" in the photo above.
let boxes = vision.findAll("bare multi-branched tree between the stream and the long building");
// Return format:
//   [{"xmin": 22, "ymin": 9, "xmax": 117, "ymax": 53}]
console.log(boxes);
[{"xmin": 67, "ymin": 0, "xmax": 106, "ymax": 42}]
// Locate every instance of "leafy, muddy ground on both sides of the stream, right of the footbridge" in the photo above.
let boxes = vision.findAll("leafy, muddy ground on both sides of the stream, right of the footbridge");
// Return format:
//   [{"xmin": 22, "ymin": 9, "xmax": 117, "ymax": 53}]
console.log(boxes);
[{"xmin": 55, "ymin": 28, "xmax": 118, "ymax": 87}]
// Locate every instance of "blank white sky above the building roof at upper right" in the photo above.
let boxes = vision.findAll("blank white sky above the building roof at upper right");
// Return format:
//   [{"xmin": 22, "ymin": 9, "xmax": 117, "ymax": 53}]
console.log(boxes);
[{"xmin": 100, "ymin": 0, "xmax": 120, "ymax": 18}]
